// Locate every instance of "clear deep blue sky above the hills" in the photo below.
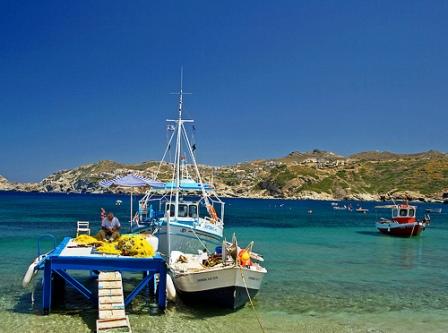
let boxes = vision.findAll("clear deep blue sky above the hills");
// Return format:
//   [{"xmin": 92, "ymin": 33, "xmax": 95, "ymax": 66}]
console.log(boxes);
[{"xmin": 0, "ymin": 0, "xmax": 448, "ymax": 181}]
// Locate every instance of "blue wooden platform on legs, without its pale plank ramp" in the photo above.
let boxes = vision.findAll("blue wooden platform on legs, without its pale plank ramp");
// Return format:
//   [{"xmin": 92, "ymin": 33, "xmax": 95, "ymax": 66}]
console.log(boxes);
[{"xmin": 39, "ymin": 237, "xmax": 166, "ymax": 314}]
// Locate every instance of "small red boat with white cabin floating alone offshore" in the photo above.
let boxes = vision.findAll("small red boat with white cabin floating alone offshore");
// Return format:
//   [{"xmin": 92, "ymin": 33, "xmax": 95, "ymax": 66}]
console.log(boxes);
[{"xmin": 376, "ymin": 203, "xmax": 430, "ymax": 237}]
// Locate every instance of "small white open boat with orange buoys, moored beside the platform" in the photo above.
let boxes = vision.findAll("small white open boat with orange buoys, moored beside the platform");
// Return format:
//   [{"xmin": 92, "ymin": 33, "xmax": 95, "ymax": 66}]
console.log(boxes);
[{"xmin": 169, "ymin": 236, "xmax": 267, "ymax": 310}]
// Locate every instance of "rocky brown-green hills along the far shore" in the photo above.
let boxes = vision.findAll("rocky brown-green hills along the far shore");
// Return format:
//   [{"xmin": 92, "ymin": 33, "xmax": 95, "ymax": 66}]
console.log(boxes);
[{"xmin": 0, "ymin": 149, "xmax": 448, "ymax": 200}]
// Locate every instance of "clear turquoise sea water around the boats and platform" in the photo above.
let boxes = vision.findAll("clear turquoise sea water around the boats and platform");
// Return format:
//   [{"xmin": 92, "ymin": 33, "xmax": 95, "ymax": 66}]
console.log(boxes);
[{"xmin": 0, "ymin": 192, "xmax": 448, "ymax": 333}]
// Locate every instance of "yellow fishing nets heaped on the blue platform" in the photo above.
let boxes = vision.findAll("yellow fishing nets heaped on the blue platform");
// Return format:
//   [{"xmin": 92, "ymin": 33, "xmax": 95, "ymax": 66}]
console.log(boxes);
[{"xmin": 74, "ymin": 235, "xmax": 155, "ymax": 258}]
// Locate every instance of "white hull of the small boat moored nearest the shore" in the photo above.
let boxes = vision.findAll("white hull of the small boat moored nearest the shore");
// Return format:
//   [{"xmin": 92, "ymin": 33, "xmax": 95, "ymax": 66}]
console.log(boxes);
[{"xmin": 173, "ymin": 266, "xmax": 266, "ymax": 310}]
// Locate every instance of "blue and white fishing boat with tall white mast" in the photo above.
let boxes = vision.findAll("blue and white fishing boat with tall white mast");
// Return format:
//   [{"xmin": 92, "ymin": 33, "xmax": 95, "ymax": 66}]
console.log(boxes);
[{"xmin": 133, "ymin": 75, "xmax": 224, "ymax": 256}]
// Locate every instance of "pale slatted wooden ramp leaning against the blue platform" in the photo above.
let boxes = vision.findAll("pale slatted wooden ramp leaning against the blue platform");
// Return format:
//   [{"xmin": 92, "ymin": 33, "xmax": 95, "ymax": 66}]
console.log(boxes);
[{"xmin": 96, "ymin": 272, "xmax": 132, "ymax": 332}]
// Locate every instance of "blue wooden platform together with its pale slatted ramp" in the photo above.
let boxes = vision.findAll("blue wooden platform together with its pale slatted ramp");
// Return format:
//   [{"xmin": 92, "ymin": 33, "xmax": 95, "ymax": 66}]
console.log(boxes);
[{"xmin": 37, "ymin": 237, "xmax": 166, "ymax": 320}]
